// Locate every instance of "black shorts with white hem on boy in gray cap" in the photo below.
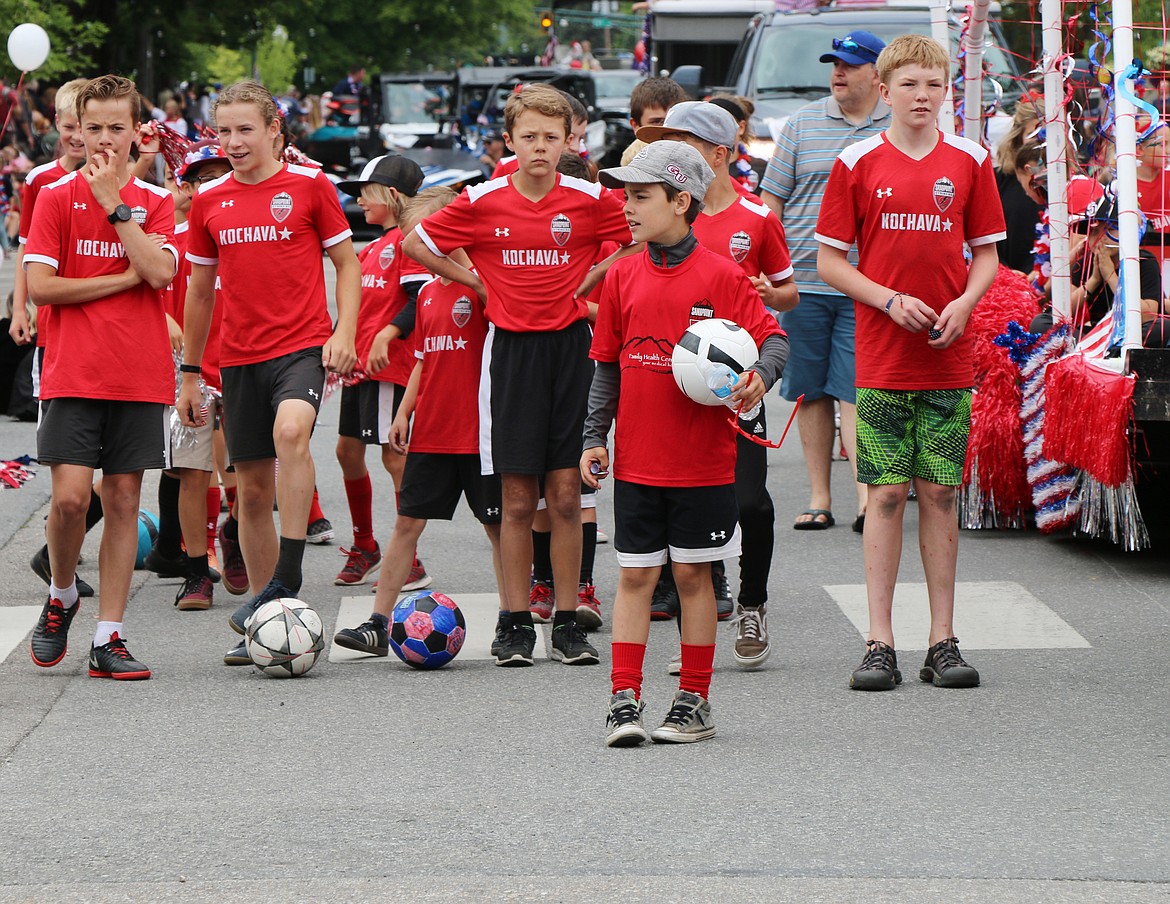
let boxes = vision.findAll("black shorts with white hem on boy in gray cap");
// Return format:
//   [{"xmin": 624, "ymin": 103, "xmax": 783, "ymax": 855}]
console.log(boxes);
[{"xmin": 613, "ymin": 481, "xmax": 741, "ymax": 568}]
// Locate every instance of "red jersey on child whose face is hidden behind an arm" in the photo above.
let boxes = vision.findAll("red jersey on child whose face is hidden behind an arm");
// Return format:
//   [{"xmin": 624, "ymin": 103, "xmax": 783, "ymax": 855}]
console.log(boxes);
[{"xmin": 411, "ymin": 274, "xmax": 488, "ymax": 455}]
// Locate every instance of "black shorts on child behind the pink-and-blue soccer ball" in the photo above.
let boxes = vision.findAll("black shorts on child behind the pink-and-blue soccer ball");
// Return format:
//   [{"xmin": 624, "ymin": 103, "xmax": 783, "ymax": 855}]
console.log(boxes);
[{"xmin": 398, "ymin": 453, "xmax": 501, "ymax": 524}]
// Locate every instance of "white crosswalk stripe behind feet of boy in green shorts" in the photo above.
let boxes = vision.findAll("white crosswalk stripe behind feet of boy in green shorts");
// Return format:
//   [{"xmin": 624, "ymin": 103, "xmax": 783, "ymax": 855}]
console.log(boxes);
[{"xmin": 825, "ymin": 581, "xmax": 1092, "ymax": 651}]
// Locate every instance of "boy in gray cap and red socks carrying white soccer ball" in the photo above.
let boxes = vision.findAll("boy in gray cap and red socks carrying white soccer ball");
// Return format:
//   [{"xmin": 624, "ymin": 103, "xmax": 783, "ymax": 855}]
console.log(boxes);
[{"xmin": 579, "ymin": 142, "xmax": 787, "ymax": 746}]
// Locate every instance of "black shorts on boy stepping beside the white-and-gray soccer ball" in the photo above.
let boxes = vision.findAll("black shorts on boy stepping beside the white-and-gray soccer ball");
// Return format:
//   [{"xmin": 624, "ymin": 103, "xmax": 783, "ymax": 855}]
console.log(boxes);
[{"xmin": 220, "ymin": 345, "xmax": 325, "ymax": 462}]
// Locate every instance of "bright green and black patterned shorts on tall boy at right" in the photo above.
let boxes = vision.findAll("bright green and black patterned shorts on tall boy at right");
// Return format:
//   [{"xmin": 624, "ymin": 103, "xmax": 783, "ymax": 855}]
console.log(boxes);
[{"xmin": 858, "ymin": 388, "xmax": 971, "ymax": 486}]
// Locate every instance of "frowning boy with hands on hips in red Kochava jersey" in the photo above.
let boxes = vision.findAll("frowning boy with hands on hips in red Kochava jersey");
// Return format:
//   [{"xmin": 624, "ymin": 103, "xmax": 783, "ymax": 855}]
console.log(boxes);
[{"xmin": 402, "ymin": 84, "xmax": 629, "ymax": 665}]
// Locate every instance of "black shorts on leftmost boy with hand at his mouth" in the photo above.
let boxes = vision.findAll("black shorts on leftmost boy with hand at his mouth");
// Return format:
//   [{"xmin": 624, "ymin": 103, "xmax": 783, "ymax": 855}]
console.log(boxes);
[{"xmin": 36, "ymin": 398, "xmax": 171, "ymax": 474}]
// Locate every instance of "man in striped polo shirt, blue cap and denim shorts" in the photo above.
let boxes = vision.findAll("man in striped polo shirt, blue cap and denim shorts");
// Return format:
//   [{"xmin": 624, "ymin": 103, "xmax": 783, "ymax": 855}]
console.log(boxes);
[{"xmin": 761, "ymin": 32, "xmax": 890, "ymax": 532}]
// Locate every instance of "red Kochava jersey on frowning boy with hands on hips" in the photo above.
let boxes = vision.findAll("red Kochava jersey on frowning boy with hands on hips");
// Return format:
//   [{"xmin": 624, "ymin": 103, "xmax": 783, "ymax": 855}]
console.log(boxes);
[{"xmin": 415, "ymin": 175, "xmax": 631, "ymax": 332}]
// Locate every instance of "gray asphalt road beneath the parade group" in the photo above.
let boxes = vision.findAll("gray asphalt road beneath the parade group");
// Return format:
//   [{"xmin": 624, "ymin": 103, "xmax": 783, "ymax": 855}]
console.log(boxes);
[{"xmin": 0, "ymin": 249, "xmax": 1170, "ymax": 904}]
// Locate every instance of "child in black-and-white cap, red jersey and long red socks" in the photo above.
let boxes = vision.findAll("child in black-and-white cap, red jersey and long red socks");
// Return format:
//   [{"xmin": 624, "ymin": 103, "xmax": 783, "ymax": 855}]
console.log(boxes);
[{"xmin": 333, "ymin": 154, "xmax": 431, "ymax": 589}]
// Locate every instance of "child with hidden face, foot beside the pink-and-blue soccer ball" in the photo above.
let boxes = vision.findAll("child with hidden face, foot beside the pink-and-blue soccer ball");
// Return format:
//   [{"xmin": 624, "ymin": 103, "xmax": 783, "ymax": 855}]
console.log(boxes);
[{"xmin": 333, "ymin": 188, "xmax": 503, "ymax": 656}]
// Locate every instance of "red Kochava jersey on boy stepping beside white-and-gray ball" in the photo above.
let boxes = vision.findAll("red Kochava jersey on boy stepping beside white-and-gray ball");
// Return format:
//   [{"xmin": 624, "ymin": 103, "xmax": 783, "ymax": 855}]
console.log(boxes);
[{"xmin": 187, "ymin": 164, "xmax": 351, "ymax": 367}]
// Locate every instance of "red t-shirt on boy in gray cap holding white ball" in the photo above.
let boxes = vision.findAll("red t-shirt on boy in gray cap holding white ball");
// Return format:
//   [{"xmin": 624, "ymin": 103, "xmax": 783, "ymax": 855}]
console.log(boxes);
[{"xmin": 590, "ymin": 246, "xmax": 782, "ymax": 486}]
